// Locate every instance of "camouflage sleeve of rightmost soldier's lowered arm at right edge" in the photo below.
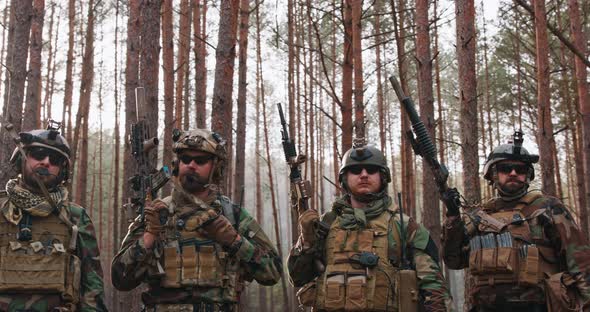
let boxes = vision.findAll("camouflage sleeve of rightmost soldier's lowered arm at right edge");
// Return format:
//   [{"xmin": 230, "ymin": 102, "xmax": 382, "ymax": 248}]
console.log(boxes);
[{"xmin": 548, "ymin": 197, "xmax": 590, "ymax": 304}]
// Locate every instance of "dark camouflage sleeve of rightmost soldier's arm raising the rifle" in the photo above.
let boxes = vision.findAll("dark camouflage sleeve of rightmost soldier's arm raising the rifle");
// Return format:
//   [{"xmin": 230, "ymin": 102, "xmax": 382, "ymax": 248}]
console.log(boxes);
[{"xmin": 441, "ymin": 217, "xmax": 469, "ymax": 270}]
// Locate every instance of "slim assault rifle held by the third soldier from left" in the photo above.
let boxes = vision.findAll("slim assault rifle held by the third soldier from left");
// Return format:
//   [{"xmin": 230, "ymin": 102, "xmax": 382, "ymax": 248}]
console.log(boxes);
[{"xmin": 277, "ymin": 103, "xmax": 330, "ymax": 272}]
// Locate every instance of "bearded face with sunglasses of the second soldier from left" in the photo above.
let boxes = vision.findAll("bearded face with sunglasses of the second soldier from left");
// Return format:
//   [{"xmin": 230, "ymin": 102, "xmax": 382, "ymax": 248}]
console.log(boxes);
[{"xmin": 178, "ymin": 150, "xmax": 213, "ymax": 193}]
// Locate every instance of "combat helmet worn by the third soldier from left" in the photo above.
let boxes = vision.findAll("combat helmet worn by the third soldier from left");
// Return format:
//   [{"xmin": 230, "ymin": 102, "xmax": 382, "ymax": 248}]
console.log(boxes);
[{"xmin": 338, "ymin": 139, "xmax": 391, "ymax": 192}]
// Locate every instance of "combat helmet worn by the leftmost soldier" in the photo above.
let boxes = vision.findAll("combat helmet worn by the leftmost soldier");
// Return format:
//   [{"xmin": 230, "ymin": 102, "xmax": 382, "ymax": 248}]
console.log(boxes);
[{"xmin": 10, "ymin": 120, "xmax": 72, "ymax": 182}]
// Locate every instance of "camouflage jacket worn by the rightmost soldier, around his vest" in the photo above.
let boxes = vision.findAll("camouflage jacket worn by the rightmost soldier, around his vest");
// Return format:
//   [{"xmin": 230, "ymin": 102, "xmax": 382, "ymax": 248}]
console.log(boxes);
[{"xmin": 442, "ymin": 192, "xmax": 590, "ymax": 310}]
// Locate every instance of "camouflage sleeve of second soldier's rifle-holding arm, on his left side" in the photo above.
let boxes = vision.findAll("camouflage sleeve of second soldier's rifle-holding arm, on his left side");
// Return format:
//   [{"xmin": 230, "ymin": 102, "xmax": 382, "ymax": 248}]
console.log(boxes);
[{"xmin": 111, "ymin": 219, "xmax": 158, "ymax": 291}]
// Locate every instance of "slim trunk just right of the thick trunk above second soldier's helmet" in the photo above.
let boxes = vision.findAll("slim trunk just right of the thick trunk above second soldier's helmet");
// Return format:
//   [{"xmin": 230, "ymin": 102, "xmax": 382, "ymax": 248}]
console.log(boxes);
[{"xmin": 233, "ymin": 0, "xmax": 250, "ymax": 201}]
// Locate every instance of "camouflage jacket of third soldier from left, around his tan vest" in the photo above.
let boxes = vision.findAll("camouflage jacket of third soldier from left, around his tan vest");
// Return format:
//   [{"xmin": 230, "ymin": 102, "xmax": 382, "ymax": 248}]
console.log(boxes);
[{"xmin": 287, "ymin": 198, "xmax": 452, "ymax": 311}]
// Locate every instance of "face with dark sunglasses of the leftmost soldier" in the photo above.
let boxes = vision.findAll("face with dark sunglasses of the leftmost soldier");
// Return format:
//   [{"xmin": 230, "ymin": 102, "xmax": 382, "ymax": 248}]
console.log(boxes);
[{"xmin": 23, "ymin": 147, "xmax": 66, "ymax": 189}]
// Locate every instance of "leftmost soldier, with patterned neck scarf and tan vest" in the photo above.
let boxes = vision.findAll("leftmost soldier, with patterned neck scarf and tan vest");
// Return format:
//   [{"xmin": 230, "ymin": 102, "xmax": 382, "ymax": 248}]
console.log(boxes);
[{"xmin": 0, "ymin": 127, "xmax": 106, "ymax": 311}]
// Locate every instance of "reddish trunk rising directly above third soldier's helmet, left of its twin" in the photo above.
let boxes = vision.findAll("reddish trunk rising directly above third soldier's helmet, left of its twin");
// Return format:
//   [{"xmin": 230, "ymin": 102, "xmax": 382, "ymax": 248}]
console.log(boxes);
[{"xmin": 340, "ymin": 0, "xmax": 353, "ymax": 154}]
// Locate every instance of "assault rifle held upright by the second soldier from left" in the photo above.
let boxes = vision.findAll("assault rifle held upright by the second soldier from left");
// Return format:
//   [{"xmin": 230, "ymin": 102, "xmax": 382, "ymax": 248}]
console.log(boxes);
[{"xmin": 125, "ymin": 87, "xmax": 170, "ymax": 222}]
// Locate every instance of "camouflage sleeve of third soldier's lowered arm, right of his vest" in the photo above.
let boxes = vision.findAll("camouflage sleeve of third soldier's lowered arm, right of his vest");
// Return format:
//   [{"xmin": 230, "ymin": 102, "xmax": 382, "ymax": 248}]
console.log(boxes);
[{"xmin": 412, "ymin": 225, "xmax": 452, "ymax": 311}]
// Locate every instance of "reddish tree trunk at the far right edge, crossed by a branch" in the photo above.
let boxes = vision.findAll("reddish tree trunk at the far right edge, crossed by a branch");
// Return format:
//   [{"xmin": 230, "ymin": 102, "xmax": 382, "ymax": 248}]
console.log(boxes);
[{"xmin": 569, "ymin": 0, "xmax": 590, "ymax": 237}]
